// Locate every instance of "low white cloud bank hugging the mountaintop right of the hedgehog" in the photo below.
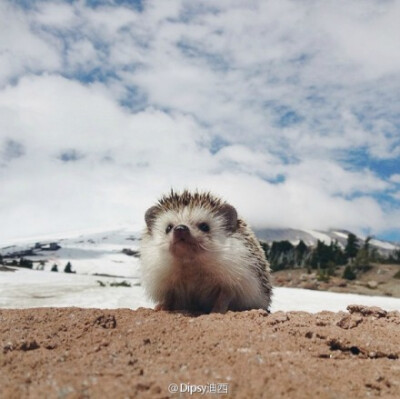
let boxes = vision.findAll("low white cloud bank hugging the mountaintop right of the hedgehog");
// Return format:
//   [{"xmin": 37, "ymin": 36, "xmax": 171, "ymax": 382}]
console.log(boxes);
[{"xmin": 193, "ymin": 173, "xmax": 388, "ymax": 232}]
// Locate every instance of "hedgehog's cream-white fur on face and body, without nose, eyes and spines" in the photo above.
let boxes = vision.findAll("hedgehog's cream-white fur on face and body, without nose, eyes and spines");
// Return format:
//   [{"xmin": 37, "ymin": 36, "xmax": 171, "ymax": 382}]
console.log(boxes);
[{"xmin": 140, "ymin": 203, "xmax": 269, "ymax": 310}]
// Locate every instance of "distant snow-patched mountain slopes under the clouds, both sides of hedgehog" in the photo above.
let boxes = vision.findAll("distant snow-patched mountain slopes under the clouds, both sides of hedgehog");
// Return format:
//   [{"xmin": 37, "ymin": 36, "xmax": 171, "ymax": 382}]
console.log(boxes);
[{"xmin": 0, "ymin": 228, "xmax": 399, "ymax": 279}]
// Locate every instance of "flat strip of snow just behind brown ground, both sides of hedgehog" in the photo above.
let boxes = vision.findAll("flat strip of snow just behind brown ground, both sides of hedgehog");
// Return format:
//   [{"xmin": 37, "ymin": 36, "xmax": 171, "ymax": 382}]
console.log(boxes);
[{"xmin": 0, "ymin": 269, "xmax": 400, "ymax": 313}]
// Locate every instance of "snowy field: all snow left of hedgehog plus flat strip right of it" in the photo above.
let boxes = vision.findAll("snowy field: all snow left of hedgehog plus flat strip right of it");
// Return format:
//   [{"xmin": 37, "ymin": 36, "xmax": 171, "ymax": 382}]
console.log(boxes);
[{"xmin": 0, "ymin": 228, "xmax": 400, "ymax": 312}]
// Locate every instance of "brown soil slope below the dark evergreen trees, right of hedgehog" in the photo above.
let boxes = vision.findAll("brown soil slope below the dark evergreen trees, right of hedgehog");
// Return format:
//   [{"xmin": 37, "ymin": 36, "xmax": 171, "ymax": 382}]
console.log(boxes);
[{"xmin": 272, "ymin": 264, "xmax": 400, "ymax": 298}]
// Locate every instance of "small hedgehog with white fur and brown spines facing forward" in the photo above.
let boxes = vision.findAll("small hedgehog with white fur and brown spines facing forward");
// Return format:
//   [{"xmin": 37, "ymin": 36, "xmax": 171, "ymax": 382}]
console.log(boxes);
[{"xmin": 140, "ymin": 190, "xmax": 272, "ymax": 313}]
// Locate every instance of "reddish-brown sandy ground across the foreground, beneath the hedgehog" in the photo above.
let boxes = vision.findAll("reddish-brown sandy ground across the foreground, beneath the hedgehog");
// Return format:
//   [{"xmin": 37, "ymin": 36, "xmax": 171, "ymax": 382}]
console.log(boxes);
[{"xmin": 0, "ymin": 306, "xmax": 400, "ymax": 399}]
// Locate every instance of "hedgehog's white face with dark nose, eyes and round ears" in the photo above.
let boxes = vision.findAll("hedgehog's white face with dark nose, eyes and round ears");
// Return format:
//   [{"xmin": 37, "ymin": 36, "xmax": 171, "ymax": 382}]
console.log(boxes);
[{"xmin": 146, "ymin": 204, "xmax": 237, "ymax": 260}]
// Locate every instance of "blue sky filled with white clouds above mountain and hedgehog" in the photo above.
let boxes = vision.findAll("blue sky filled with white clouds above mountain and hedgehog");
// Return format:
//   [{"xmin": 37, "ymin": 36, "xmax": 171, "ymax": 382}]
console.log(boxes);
[{"xmin": 0, "ymin": 0, "xmax": 400, "ymax": 243}]
